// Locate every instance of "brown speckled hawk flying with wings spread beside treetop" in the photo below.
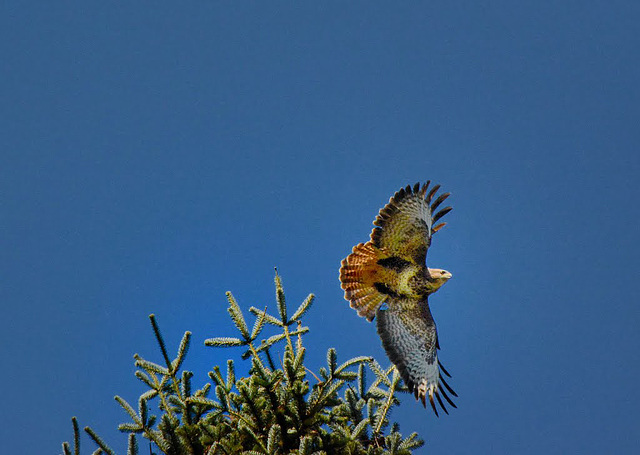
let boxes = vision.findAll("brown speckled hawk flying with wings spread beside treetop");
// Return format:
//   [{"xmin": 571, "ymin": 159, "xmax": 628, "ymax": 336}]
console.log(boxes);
[{"xmin": 340, "ymin": 182, "xmax": 458, "ymax": 415}]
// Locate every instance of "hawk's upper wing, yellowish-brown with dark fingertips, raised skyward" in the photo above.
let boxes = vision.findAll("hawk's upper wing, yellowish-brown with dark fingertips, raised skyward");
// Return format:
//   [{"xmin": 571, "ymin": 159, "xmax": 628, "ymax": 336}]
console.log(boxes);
[{"xmin": 371, "ymin": 182, "xmax": 451, "ymax": 265}]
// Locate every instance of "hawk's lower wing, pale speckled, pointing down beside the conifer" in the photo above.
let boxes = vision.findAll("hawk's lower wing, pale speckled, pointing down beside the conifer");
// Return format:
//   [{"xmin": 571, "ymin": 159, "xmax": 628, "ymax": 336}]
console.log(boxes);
[{"xmin": 376, "ymin": 298, "xmax": 458, "ymax": 415}]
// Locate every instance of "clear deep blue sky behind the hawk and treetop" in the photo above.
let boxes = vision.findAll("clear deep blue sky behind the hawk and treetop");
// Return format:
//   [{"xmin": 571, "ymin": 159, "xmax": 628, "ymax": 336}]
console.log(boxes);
[{"xmin": 0, "ymin": 1, "xmax": 640, "ymax": 454}]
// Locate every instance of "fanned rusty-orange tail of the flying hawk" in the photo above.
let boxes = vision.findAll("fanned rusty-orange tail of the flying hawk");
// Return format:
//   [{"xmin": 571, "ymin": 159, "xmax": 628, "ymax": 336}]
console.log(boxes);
[{"xmin": 340, "ymin": 242, "xmax": 390, "ymax": 321}]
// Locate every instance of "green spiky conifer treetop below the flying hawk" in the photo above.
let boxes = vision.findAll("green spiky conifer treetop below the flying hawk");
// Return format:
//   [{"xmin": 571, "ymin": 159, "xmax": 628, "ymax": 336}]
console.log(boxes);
[{"xmin": 62, "ymin": 272, "xmax": 423, "ymax": 455}]
